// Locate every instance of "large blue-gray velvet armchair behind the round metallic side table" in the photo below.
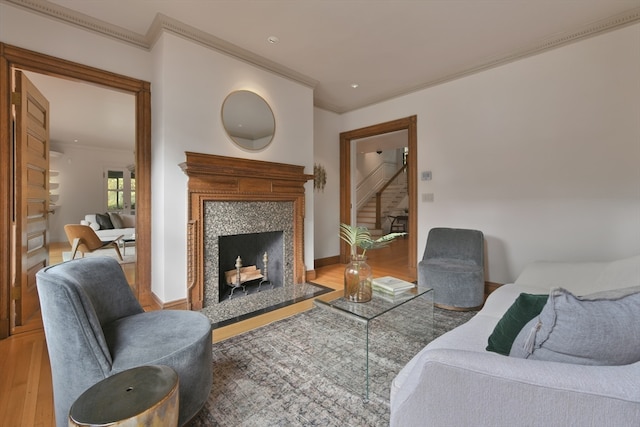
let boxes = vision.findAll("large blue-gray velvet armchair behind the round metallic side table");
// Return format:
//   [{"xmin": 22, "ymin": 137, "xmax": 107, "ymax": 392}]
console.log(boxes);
[{"xmin": 36, "ymin": 257, "xmax": 212, "ymax": 427}]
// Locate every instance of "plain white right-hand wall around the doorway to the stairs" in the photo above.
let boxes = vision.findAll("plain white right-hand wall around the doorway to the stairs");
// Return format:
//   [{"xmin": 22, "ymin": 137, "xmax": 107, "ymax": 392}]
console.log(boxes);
[{"xmin": 336, "ymin": 24, "xmax": 640, "ymax": 283}]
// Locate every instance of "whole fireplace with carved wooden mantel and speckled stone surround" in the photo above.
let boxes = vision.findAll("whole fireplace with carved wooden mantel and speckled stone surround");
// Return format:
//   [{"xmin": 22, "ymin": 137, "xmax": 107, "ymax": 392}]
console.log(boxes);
[{"xmin": 180, "ymin": 152, "xmax": 320, "ymax": 322}]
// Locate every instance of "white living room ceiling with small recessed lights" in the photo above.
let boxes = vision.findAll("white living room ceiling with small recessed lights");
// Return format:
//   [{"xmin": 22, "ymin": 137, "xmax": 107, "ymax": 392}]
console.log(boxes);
[{"xmin": 6, "ymin": 0, "xmax": 640, "ymax": 150}]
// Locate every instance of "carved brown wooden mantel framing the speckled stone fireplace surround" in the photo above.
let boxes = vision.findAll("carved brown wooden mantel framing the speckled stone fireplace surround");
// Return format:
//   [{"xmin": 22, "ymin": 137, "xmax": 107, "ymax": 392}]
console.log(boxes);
[{"xmin": 180, "ymin": 151, "xmax": 313, "ymax": 310}]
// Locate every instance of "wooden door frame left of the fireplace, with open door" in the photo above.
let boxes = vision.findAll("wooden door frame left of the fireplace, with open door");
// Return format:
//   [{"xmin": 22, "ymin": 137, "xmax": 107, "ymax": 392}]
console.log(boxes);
[{"xmin": 0, "ymin": 43, "xmax": 152, "ymax": 339}]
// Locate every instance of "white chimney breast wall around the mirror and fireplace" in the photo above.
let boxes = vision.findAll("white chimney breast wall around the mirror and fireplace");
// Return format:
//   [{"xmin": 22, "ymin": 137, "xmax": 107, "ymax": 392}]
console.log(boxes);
[{"xmin": 152, "ymin": 33, "xmax": 314, "ymax": 301}]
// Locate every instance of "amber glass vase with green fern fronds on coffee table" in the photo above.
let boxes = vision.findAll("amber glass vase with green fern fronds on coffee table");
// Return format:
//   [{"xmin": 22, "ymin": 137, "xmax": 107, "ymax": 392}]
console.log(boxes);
[{"xmin": 340, "ymin": 223, "xmax": 406, "ymax": 302}]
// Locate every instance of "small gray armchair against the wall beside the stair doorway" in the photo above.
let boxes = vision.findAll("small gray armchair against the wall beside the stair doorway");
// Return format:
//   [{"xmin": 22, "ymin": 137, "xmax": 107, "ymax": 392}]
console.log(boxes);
[{"xmin": 418, "ymin": 228, "xmax": 484, "ymax": 310}]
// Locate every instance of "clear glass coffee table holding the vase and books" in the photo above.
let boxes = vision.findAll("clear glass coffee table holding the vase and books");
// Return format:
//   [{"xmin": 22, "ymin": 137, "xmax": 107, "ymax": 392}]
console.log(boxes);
[{"xmin": 314, "ymin": 286, "xmax": 433, "ymax": 400}]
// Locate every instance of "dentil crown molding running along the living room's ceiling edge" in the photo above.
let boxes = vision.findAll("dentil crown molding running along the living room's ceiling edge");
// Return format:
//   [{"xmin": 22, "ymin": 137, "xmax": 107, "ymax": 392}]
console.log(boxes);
[{"xmin": 6, "ymin": 0, "xmax": 640, "ymax": 114}]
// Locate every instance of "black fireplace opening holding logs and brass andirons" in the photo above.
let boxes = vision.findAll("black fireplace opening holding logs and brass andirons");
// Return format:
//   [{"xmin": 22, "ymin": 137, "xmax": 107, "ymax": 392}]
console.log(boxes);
[{"xmin": 218, "ymin": 231, "xmax": 284, "ymax": 302}]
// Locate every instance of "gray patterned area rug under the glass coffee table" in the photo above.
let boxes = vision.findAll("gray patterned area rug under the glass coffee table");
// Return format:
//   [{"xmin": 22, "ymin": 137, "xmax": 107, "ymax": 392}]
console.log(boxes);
[{"xmin": 191, "ymin": 304, "xmax": 475, "ymax": 427}]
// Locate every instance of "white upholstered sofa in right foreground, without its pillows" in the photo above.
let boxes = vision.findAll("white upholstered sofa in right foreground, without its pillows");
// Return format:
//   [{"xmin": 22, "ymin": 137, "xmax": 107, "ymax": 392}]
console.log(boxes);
[{"xmin": 391, "ymin": 256, "xmax": 640, "ymax": 427}]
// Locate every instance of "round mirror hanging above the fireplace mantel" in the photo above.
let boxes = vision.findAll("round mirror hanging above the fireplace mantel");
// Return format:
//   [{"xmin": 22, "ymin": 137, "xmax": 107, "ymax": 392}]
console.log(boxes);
[{"xmin": 222, "ymin": 90, "xmax": 276, "ymax": 150}]
